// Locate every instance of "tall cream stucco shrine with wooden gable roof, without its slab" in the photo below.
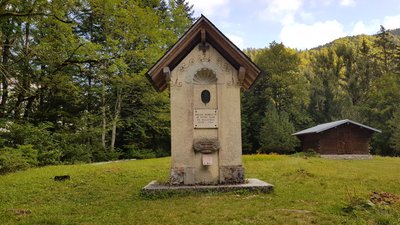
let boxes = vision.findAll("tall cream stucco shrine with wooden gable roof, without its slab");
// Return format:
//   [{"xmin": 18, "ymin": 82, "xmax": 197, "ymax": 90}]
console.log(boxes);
[{"xmin": 147, "ymin": 15, "xmax": 274, "ymax": 190}]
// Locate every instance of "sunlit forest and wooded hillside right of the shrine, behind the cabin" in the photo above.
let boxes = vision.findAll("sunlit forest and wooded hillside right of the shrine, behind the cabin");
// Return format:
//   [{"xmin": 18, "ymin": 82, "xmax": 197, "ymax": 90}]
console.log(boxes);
[{"xmin": 242, "ymin": 26, "xmax": 400, "ymax": 156}]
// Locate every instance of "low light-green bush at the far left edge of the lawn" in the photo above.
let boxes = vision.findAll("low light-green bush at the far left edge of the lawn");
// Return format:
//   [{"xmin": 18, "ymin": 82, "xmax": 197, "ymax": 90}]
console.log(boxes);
[{"xmin": 0, "ymin": 145, "xmax": 38, "ymax": 174}]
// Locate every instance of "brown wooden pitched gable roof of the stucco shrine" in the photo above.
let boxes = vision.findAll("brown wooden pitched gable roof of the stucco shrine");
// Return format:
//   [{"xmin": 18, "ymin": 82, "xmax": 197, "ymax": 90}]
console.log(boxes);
[{"xmin": 146, "ymin": 15, "xmax": 261, "ymax": 91}]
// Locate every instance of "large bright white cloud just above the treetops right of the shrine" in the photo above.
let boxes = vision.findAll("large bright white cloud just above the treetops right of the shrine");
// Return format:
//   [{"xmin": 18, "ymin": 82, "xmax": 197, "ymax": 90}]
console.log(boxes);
[{"xmin": 280, "ymin": 20, "xmax": 347, "ymax": 49}]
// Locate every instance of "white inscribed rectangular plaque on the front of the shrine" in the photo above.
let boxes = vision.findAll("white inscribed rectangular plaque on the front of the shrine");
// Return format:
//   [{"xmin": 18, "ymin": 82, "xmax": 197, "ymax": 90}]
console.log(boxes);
[{"xmin": 193, "ymin": 109, "xmax": 218, "ymax": 128}]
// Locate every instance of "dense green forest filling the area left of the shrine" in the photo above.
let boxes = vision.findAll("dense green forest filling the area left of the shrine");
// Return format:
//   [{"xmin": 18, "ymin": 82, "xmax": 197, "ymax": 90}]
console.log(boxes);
[{"xmin": 0, "ymin": 0, "xmax": 194, "ymax": 173}]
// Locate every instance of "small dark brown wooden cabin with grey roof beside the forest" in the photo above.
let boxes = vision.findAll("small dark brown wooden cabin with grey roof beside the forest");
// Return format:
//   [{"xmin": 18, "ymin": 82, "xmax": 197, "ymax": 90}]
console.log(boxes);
[{"xmin": 293, "ymin": 119, "xmax": 381, "ymax": 155}]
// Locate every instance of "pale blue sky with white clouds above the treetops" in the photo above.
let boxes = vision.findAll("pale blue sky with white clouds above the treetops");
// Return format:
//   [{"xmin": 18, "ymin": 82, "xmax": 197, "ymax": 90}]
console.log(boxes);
[{"xmin": 187, "ymin": 0, "xmax": 400, "ymax": 50}]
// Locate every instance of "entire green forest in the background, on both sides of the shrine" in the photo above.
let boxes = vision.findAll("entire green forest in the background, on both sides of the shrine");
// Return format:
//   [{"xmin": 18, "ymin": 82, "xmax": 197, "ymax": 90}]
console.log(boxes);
[{"xmin": 0, "ymin": 0, "xmax": 400, "ymax": 173}]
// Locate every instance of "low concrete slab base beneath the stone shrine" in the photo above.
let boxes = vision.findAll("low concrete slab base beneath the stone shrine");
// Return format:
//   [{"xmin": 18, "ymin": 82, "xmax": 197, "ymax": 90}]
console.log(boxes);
[{"xmin": 142, "ymin": 178, "xmax": 274, "ymax": 194}]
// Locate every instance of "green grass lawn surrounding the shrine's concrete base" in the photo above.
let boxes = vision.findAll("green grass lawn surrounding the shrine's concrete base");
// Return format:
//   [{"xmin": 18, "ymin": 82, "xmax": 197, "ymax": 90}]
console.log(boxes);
[{"xmin": 0, "ymin": 155, "xmax": 400, "ymax": 225}]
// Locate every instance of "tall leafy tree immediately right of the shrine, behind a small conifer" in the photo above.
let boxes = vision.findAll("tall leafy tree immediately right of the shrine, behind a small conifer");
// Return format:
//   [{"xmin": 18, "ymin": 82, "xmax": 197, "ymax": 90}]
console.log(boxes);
[{"xmin": 242, "ymin": 42, "xmax": 310, "ymax": 152}]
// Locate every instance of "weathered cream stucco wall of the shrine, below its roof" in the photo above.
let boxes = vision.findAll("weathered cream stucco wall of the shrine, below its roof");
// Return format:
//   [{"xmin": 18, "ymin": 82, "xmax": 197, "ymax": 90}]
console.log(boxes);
[{"xmin": 170, "ymin": 45, "xmax": 244, "ymax": 184}]
